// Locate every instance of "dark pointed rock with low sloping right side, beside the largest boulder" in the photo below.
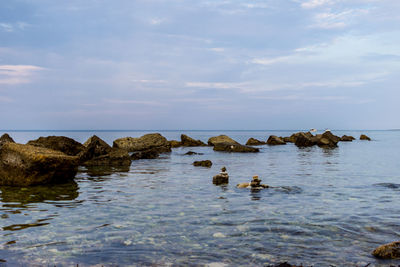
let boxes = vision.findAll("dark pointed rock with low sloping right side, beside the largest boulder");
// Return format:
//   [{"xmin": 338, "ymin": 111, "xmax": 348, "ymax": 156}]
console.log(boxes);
[{"xmin": 78, "ymin": 135, "xmax": 131, "ymax": 166}]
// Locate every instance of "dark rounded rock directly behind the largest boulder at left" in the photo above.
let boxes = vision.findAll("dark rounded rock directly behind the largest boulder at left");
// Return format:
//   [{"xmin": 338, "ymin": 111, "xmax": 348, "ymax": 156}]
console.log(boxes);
[{"xmin": 27, "ymin": 136, "xmax": 85, "ymax": 156}]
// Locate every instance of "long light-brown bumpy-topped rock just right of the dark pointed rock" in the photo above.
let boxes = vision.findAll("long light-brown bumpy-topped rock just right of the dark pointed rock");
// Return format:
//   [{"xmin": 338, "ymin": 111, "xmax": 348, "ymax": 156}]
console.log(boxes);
[{"xmin": 113, "ymin": 133, "xmax": 171, "ymax": 153}]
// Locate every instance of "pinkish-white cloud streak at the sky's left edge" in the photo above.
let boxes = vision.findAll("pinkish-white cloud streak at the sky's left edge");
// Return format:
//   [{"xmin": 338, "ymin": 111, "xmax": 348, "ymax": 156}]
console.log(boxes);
[{"xmin": 0, "ymin": 65, "xmax": 44, "ymax": 84}]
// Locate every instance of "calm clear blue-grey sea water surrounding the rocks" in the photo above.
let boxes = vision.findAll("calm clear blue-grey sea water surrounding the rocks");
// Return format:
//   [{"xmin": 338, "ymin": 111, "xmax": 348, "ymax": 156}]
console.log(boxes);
[{"xmin": 0, "ymin": 131, "xmax": 400, "ymax": 266}]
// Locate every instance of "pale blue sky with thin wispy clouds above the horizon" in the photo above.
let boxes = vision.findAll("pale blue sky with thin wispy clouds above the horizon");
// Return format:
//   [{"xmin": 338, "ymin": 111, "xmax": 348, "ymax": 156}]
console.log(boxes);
[{"xmin": 0, "ymin": 0, "xmax": 400, "ymax": 130}]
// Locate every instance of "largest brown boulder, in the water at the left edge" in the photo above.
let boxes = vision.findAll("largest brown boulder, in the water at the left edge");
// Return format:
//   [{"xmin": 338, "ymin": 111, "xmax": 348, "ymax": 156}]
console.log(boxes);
[{"xmin": 0, "ymin": 143, "xmax": 78, "ymax": 186}]
